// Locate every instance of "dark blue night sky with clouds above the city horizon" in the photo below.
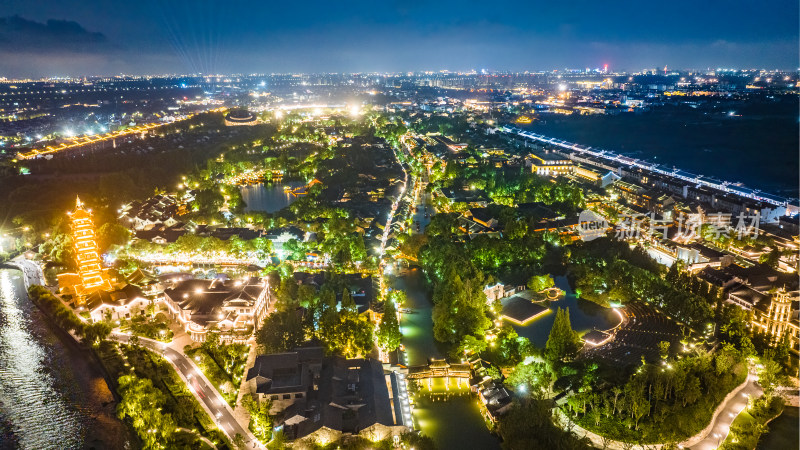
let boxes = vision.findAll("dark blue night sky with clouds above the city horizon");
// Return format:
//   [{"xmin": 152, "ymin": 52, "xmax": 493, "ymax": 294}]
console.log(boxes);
[{"xmin": 0, "ymin": 0, "xmax": 799, "ymax": 77}]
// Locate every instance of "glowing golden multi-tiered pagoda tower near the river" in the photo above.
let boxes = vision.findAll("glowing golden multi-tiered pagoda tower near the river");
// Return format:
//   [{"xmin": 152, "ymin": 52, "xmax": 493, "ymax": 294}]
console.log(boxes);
[{"xmin": 68, "ymin": 197, "xmax": 111, "ymax": 304}]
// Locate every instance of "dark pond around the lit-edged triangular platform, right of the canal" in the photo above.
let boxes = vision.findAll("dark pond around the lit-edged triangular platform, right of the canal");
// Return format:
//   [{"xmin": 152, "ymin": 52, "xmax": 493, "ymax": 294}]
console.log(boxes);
[{"xmin": 512, "ymin": 276, "xmax": 619, "ymax": 348}]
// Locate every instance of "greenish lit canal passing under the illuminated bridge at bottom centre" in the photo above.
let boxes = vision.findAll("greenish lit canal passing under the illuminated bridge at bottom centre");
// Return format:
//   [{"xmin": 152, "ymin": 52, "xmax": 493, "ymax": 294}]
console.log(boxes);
[{"xmin": 394, "ymin": 268, "xmax": 500, "ymax": 450}]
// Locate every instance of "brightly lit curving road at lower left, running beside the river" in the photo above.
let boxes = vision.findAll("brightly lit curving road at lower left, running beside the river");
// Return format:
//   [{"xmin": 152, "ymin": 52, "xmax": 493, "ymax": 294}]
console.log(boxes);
[{"xmin": 112, "ymin": 332, "xmax": 265, "ymax": 449}]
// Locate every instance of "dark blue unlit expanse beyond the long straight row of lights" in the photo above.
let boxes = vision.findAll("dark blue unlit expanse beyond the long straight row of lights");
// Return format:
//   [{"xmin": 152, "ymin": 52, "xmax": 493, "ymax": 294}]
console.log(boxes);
[{"xmin": 520, "ymin": 106, "xmax": 799, "ymax": 196}]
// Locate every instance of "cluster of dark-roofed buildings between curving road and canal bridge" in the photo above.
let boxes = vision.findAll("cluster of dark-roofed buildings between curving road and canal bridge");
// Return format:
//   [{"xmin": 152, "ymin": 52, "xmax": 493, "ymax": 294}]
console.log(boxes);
[{"xmin": 246, "ymin": 347, "xmax": 411, "ymax": 441}]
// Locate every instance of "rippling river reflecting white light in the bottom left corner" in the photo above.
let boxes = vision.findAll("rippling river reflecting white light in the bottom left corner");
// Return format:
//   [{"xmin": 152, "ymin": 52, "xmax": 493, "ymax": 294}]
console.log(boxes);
[{"xmin": 0, "ymin": 269, "xmax": 135, "ymax": 450}]
